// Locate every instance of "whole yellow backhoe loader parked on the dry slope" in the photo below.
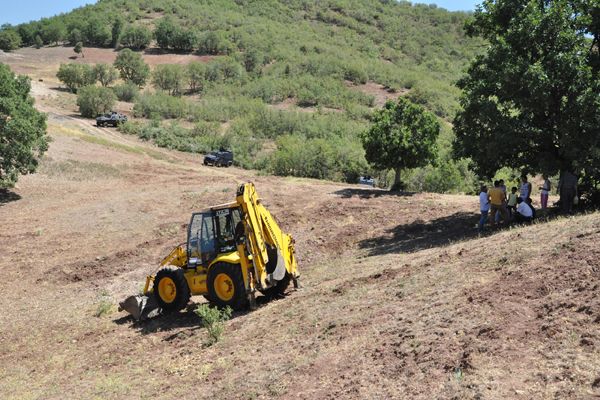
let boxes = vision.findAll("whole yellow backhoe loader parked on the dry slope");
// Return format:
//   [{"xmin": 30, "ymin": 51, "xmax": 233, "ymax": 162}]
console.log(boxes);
[{"xmin": 120, "ymin": 183, "xmax": 300, "ymax": 320}]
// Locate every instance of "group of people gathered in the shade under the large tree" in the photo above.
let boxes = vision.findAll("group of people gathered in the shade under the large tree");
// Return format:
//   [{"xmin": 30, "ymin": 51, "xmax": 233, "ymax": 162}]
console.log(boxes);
[{"xmin": 478, "ymin": 175, "xmax": 552, "ymax": 232}]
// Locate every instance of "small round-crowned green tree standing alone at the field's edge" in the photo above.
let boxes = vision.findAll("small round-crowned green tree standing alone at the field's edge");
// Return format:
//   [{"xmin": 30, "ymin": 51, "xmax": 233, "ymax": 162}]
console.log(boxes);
[{"xmin": 361, "ymin": 97, "xmax": 440, "ymax": 190}]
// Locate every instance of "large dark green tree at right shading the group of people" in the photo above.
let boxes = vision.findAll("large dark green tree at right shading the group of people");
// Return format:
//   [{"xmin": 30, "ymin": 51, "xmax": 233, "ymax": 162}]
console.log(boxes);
[{"xmin": 454, "ymin": 0, "xmax": 600, "ymax": 202}]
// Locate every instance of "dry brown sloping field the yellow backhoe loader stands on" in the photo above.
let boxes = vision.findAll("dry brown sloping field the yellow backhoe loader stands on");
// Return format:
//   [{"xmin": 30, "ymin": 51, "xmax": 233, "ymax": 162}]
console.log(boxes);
[{"xmin": 0, "ymin": 50, "xmax": 600, "ymax": 399}]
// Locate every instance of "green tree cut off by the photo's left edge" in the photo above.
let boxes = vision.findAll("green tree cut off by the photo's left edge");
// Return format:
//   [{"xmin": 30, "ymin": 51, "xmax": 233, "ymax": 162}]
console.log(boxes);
[{"xmin": 0, "ymin": 64, "xmax": 48, "ymax": 188}]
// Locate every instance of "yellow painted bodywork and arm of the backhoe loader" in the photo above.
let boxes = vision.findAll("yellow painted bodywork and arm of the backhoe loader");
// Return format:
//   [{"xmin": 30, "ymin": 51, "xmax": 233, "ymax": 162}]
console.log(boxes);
[{"xmin": 132, "ymin": 183, "xmax": 299, "ymax": 314}]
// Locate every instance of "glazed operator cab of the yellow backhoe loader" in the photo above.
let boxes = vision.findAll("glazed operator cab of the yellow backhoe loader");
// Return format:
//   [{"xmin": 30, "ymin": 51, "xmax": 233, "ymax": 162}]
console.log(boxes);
[{"xmin": 187, "ymin": 203, "xmax": 242, "ymax": 268}]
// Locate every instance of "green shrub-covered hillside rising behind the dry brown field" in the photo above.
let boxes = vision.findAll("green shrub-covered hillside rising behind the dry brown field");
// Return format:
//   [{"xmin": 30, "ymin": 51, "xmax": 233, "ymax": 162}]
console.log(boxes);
[{"xmin": 0, "ymin": 0, "xmax": 482, "ymax": 192}]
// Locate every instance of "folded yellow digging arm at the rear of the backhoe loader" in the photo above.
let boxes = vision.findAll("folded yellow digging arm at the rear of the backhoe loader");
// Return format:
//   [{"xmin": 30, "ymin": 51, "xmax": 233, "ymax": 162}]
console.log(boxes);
[{"xmin": 236, "ymin": 183, "xmax": 299, "ymax": 288}]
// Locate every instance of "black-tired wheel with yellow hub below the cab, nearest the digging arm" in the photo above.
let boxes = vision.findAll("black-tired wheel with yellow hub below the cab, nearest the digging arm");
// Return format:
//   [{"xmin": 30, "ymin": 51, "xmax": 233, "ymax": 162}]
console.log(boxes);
[{"xmin": 206, "ymin": 262, "xmax": 248, "ymax": 310}]
